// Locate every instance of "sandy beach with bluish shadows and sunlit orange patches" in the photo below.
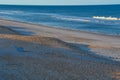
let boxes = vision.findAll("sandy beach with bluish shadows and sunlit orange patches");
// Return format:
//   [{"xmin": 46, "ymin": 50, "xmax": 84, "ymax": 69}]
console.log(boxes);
[{"xmin": 0, "ymin": 19, "xmax": 120, "ymax": 80}]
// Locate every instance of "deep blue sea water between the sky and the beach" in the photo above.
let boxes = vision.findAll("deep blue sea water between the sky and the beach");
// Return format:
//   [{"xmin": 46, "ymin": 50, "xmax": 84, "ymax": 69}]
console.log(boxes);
[{"xmin": 0, "ymin": 5, "xmax": 120, "ymax": 36}]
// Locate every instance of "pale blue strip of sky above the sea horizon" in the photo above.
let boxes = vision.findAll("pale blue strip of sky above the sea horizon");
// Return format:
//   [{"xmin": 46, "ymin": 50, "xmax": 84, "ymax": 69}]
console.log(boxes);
[{"xmin": 0, "ymin": 0, "xmax": 120, "ymax": 5}]
